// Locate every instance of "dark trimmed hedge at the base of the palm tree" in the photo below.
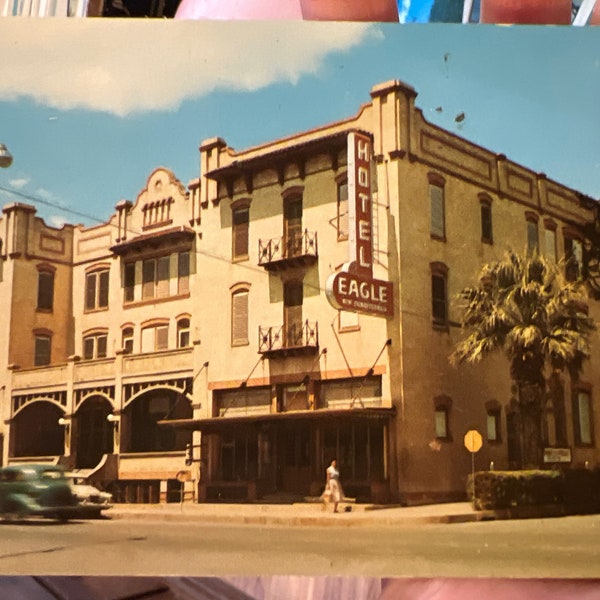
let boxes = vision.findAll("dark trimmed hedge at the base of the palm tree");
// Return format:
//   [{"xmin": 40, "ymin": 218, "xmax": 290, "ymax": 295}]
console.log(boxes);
[{"xmin": 467, "ymin": 469, "xmax": 600, "ymax": 514}]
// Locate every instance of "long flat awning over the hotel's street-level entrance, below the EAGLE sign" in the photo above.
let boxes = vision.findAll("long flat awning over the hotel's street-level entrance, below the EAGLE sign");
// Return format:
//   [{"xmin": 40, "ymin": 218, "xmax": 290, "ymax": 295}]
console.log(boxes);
[{"xmin": 158, "ymin": 408, "xmax": 396, "ymax": 433}]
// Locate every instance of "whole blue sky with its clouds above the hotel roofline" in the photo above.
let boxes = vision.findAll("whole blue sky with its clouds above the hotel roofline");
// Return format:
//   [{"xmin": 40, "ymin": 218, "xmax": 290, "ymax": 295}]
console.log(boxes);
[{"xmin": 0, "ymin": 19, "xmax": 600, "ymax": 225}]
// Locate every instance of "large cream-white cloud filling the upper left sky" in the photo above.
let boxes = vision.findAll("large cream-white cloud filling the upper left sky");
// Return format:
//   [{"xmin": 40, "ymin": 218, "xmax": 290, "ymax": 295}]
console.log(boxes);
[{"xmin": 0, "ymin": 19, "xmax": 378, "ymax": 116}]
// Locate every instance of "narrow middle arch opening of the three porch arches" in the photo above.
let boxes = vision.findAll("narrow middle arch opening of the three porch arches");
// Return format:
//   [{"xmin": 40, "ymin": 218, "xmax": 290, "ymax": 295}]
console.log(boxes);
[{"xmin": 73, "ymin": 396, "xmax": 113, "ymax": 469}]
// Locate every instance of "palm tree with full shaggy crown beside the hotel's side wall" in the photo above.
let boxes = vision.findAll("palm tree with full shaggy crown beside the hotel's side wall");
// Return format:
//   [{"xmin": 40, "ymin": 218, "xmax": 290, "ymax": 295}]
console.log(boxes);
[{"xmin": 450, "ymin": 251, "xmax": 595, "ymax": 468}]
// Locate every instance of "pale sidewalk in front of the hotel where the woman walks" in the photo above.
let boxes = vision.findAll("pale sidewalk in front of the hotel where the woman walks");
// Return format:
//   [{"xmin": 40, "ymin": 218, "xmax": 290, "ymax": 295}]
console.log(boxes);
[{"xmin": 109, "ymin": 502, "xmax": 495, "ymax": 527}]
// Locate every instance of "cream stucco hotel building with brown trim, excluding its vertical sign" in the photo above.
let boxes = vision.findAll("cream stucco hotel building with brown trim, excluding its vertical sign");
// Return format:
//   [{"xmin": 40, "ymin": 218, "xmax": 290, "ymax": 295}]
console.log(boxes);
[{"xmin": 0, "ymin": 81, "xmax": 600, "ymax": 502}]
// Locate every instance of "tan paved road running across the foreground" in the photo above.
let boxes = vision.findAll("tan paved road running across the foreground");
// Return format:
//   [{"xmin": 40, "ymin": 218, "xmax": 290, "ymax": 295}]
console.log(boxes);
[{"xmin": 0, "ymin": 515, "xmax": 600, "ymax": 577}]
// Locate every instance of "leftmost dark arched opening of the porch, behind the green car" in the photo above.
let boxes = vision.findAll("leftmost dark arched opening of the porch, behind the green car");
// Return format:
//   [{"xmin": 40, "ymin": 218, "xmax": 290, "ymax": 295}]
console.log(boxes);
[{"xmin": 11, "ymin": 400, "xmax": 65, "ymax": 457}]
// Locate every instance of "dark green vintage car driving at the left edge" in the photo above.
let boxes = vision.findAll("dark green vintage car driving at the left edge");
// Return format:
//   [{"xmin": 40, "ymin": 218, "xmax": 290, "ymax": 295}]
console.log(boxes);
[{"xmin": 0, "ymin": 464, "xmax": 79, "ymax": 521}]
